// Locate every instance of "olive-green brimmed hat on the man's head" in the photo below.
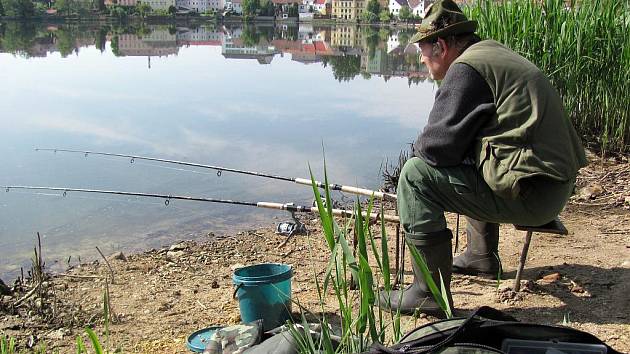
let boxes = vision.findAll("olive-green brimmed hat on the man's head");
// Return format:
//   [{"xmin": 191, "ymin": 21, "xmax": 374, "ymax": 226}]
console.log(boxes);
[{"xmin": 409, "ymin": 0, "xmax": 477, "ymax": 43}]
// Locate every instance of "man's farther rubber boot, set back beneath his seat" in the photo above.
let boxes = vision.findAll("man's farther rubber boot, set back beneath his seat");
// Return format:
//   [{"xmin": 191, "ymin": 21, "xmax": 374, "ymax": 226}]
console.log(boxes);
[{"xmin": 453, "ymin": 217, "xmax": 503, "ymax": 279}]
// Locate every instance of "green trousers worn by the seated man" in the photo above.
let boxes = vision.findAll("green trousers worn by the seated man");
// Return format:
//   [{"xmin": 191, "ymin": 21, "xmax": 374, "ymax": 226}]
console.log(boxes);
[{"xmin": 397, "ymin": 157, "xmax": 575, "ymax": 241}]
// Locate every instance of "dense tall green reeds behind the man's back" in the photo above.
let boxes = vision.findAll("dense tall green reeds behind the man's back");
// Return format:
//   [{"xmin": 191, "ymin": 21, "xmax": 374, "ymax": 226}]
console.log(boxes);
[{"xmin": 463, "ymin": 0, "xmax": 630, "ymax": 152}]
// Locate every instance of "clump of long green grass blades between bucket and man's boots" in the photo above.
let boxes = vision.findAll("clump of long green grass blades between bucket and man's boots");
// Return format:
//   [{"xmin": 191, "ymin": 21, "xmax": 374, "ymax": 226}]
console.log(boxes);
[{"xmin": 291, "ymin": 161, "xmax": 451, "ymax": 353}]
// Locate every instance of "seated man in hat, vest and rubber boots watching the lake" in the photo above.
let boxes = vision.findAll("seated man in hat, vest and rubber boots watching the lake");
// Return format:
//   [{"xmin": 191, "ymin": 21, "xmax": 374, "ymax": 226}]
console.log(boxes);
[{"xmin": 380, "ymin": 0, "xmax": 586, "ymax": 314}]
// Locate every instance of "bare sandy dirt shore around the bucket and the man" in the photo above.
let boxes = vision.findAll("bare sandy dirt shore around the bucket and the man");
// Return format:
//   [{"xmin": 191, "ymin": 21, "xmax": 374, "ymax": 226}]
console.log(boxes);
[{"xmin": 0, "ymin": 156, "xmax": 630, "ymax": 353}]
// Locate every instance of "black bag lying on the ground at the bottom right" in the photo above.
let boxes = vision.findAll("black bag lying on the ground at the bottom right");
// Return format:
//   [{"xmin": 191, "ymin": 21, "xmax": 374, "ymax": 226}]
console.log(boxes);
[{"xmin": 364, "ymin": 306, "xmax": 619, "ymax": 354}]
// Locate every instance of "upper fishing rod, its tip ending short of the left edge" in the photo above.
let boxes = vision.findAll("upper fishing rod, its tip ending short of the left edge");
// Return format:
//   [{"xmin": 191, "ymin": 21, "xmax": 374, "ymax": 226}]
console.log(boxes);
[{"xmin": 35, "ymin": 148, "xmax": 396, "ymax": 201}]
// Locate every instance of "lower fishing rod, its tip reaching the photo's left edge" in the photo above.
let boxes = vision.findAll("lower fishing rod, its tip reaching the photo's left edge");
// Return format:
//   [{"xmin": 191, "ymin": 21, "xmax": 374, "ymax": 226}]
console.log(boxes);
[{"xmin": 0, "ymin": 186, "xmax": 399, "ymax": 223}]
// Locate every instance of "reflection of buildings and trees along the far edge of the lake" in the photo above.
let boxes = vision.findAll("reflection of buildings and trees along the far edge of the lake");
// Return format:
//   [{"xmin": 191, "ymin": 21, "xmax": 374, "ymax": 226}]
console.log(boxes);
[{"xmin": 0, "ymin": 23, "xmax": 428, "ymax": 83}]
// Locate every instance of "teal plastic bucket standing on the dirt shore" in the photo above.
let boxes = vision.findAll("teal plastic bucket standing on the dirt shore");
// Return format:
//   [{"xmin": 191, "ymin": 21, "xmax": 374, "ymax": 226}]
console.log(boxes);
[{"xmin": 232, "ymin": 263, "xmax": 293, "ymax": 331}]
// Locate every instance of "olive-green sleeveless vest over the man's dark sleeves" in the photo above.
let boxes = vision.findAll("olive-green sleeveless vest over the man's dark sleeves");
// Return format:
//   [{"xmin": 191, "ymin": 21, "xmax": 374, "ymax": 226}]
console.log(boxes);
[{"xmin": 455, "ymin": 40, "xmax": 586, "ymax": 198}]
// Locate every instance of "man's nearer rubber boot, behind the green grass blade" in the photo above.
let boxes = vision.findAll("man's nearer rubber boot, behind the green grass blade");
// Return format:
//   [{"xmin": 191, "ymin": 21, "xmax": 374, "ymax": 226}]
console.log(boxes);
[{"xmin": 379, "ymin": 230, "xmax": 453, "ymax": 317}]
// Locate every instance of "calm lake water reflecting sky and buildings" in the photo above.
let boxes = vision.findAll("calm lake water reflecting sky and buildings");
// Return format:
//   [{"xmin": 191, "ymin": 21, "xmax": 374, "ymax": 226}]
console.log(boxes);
[{"xmin": 0, "ymin": 23, "xmax": 436, "ymax": 280}]
